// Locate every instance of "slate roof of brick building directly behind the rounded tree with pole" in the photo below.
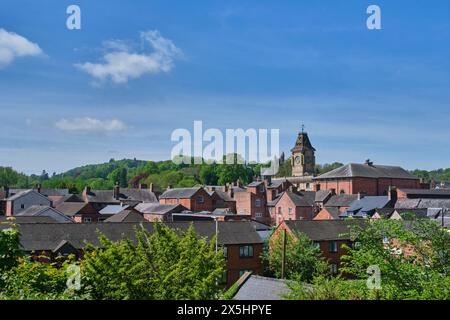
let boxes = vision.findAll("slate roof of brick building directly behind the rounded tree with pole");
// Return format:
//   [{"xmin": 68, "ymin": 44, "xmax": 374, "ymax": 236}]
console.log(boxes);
[{"xmin": 283, "ymin": 220, "xmax": 365, "ymax": 241}]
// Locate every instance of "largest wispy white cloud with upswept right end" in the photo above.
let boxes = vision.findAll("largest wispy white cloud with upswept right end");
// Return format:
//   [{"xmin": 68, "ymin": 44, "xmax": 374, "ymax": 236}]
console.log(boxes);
[{"xmin": 75, "ymin": 30, "xmax": 182, "ymax": 83}]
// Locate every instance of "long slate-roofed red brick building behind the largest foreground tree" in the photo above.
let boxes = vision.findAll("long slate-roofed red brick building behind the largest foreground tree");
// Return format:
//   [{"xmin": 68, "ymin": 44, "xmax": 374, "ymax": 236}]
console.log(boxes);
[{"xmin": 0, "ymin": 221, "xmax": 263, "ymax": 287}]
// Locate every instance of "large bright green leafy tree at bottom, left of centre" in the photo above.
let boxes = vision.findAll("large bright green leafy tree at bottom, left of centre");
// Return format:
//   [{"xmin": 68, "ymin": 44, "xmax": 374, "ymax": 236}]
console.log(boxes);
[{"xmin": 82, "ymin": 224, "xmax": 224, "ymax": 299}]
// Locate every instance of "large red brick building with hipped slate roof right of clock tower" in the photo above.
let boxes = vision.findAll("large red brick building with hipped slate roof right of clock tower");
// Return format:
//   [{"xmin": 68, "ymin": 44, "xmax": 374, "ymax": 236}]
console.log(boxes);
[{"xmin": 314, "ymin": 160, "xmax": 421, "ymax": 196}]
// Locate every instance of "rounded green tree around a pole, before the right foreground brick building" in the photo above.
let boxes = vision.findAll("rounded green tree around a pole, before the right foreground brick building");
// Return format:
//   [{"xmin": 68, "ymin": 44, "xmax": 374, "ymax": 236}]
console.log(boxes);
[{"xmin": 262, "ymin": 232, "xmax": 328, "ymax": 281}]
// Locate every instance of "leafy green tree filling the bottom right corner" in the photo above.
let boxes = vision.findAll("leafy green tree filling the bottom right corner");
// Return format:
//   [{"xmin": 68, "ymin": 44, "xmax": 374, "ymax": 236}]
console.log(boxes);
[{"xmin": 342, "ymin": 219, "xmax": 450, "ymax": 299}]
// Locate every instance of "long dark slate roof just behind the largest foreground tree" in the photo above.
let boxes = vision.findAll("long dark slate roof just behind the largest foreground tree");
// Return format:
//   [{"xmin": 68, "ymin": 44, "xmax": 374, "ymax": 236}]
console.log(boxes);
[{"xmin": 0, "ymin": 221, "xmax": 263, "ymax": 251}]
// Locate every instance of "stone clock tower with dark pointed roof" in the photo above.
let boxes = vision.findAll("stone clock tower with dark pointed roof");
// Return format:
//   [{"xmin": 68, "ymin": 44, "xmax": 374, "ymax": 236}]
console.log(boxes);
[{"xmin": 291, "ymin": 125, "xmax": 316, "ymax": 177}]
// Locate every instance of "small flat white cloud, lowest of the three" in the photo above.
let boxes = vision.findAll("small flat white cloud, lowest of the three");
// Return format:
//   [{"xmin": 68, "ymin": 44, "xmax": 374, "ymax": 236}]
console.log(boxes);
[{"xmin": 55, "ymin": 117, "xmax": 127, "ymax": 133}]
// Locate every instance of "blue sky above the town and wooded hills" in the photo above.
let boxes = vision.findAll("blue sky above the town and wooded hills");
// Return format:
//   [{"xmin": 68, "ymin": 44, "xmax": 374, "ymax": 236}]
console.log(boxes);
[{"xmin": 0, "ymin": 0, "xmax": 450, "ymax": 173}]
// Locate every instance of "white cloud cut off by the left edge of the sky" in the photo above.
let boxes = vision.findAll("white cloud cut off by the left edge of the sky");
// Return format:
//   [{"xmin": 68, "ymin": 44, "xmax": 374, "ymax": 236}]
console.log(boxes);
[{"xmin": 0, "ymin": 28, "xmax": 42, "ymax": 68}]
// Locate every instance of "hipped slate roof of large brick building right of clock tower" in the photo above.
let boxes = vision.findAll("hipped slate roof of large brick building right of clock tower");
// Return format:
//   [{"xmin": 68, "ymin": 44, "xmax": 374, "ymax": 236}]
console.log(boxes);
[{"xmin": 314, "ymin": 163, "xmax": 418, "ymax": 180}]
